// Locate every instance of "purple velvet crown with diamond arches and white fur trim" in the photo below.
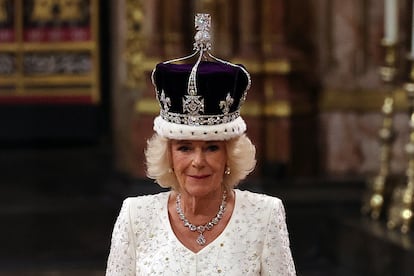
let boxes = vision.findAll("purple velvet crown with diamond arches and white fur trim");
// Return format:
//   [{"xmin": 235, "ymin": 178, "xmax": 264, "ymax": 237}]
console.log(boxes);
[{"xmin": 151, "ymin": 14, "xmax": 251, "ymax": 140}]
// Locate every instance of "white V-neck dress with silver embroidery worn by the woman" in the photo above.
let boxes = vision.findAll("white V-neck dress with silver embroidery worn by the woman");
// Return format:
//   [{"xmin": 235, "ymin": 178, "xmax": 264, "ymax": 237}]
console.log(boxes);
[{"xmin": 106, "ymin": 189, "xmax": 296, "ymax": 276}]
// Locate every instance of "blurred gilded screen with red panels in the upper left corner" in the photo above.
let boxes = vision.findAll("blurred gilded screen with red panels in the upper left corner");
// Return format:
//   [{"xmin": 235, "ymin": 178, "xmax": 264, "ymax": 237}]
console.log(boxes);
[{"xmin": 0, "ymin": 0, "xmax": 100, "ymax": 104}]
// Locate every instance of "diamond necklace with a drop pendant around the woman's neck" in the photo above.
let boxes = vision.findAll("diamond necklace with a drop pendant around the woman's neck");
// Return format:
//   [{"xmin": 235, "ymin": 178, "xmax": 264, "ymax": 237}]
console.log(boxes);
[{"xmin": 175, "ymin": 191, "xmax": 227, "ymax": 245}]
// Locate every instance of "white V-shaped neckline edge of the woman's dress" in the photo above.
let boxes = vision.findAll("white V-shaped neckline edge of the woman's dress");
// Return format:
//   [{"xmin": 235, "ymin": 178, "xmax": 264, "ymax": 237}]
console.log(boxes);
[{"xmin": 163, "ymin": 189, "xmax": 239, "ymax": 255}]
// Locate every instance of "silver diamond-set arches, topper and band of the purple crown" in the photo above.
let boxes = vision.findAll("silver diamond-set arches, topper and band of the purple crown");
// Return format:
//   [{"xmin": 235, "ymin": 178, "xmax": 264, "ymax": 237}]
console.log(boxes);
[{"xmin": 152, "ymin": 13, "xmax": 251, "ymax": 125}]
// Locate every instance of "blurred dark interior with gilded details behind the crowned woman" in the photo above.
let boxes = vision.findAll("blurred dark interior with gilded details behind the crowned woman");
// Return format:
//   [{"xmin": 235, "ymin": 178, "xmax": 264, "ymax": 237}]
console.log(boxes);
[{"xmin": 0, "ymin": 0, "xmax": 414, "ymax": 276}]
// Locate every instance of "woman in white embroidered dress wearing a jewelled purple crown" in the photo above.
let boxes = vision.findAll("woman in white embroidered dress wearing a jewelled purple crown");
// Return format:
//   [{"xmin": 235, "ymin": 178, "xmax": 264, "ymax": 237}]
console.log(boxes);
[{"xmin": 107, "ymin": 15, "xmax": 295, "ymax": 276}]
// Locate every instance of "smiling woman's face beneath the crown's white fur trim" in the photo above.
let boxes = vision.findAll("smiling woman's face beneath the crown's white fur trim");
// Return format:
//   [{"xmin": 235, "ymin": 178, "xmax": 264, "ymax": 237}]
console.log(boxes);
[{"xmin": 171, "ymin": 140, "xmax": 227, "ymax": 196}]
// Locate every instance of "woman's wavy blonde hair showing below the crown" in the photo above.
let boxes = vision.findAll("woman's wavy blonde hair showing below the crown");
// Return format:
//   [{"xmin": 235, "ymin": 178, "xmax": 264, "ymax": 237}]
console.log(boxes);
[{"xmin": 145, "ymin": 133, "xmax": 256, "ymax": 190}]
